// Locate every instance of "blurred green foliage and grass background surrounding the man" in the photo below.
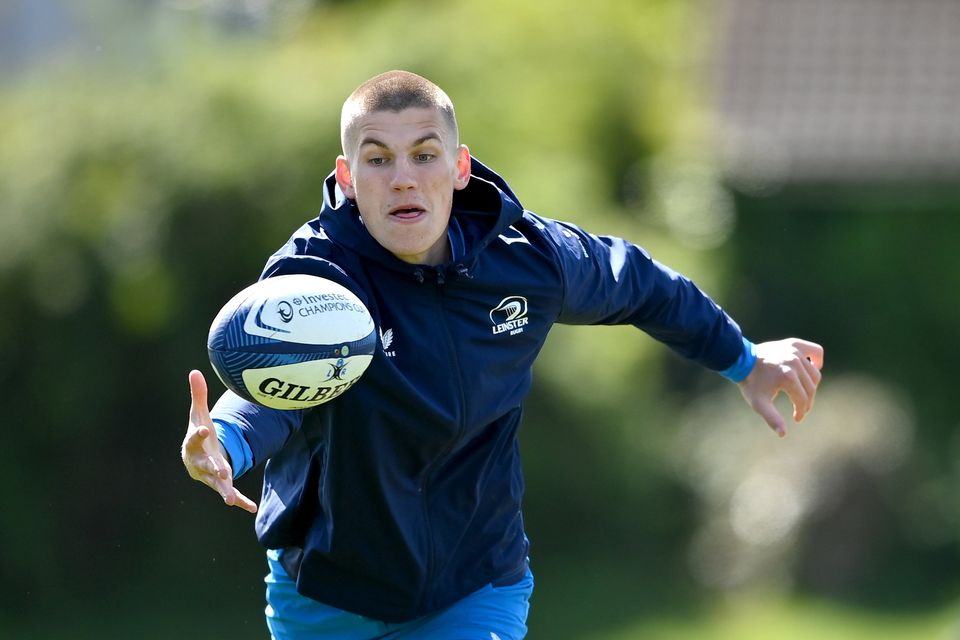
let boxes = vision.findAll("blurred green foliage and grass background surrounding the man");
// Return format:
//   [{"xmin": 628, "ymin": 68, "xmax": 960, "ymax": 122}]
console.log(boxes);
[{"xmin": 0, "ymin": 0, "xmax": 960, "ymax": 639}]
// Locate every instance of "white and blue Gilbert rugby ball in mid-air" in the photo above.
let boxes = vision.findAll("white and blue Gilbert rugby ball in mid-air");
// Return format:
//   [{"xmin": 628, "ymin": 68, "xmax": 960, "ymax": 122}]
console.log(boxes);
[{"xmin": 207, "ymin": 274, "xmax": 377, "ymax": 410}]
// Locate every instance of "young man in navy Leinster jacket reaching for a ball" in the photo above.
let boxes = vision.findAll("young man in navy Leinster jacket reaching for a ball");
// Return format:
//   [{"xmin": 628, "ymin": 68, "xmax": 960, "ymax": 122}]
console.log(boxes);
[{"xmin": 182, "ymin": 71, "xmax": 823, "ymax": 640}]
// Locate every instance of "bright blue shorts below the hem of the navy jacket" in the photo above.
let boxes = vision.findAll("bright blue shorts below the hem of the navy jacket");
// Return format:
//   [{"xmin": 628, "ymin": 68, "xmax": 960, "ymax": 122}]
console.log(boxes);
[{"xmin": 264, "ymin": 550, "xmax": 533, "ymax": 640}]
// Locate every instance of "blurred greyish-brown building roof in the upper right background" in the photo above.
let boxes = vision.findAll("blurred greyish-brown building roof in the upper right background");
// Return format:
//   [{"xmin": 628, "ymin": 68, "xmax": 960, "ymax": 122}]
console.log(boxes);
[{"xmin": 710, "ymin": 0, "xmax": 960, "ymax": 182}]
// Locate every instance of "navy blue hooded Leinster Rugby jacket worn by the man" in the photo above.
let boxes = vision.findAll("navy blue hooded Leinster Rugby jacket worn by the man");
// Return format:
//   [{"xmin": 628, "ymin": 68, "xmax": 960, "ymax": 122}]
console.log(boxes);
[{"xmin": 213, "ymin": 161, "xmax": 744, "ymax": 621}]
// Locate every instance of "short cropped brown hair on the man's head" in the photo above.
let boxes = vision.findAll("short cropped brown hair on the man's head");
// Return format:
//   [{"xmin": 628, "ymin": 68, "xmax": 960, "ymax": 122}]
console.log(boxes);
[{"xmin": 340, "ymin": 70, "xmax": 460, "ymax": 155}]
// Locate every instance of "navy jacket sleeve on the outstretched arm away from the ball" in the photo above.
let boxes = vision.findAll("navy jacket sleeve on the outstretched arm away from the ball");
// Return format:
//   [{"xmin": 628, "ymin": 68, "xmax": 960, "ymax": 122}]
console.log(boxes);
[{"xmin": 542, "ymin": 215, "xmax": 752, "ymax": 381}]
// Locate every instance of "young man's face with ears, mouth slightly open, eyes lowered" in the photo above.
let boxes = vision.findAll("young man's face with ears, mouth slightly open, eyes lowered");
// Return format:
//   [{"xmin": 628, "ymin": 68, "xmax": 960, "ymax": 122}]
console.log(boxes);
[{"xmin": 336, "ymin": 108, "xmax": 470, "ymax": 265}]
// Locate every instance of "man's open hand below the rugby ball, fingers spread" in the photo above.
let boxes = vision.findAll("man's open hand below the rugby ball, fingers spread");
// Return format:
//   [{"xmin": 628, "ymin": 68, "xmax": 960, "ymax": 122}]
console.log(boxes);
[{"xmin": 180, "ymin": 370, "xmax": 257, "ymax": 513}]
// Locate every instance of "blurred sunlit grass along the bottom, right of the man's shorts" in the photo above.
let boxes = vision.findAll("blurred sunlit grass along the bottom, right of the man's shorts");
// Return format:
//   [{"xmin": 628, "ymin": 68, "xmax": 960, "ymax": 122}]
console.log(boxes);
[{"xmin": 529, "ymin": 558, "xmax": 960, "ymax": 640}]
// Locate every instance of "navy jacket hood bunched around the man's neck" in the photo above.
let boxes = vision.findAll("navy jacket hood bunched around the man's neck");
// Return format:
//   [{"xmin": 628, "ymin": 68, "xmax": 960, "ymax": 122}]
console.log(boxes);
[{"xmin": 319, "ymin": 156, "xmax": 523, "ymax": 273}]
